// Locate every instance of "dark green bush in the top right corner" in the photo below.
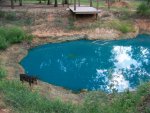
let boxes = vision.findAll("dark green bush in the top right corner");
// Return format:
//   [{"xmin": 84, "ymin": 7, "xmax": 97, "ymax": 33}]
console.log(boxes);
[{"xmin": 137, "ymin": 3, "xmax": 150, "ymax": 17}]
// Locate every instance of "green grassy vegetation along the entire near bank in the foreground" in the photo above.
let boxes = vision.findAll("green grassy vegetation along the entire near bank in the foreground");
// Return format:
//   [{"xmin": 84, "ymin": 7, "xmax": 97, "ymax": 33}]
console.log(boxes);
[{"xmin": 0, "ymin": 68, "xmax": 150, "ymax": 113}]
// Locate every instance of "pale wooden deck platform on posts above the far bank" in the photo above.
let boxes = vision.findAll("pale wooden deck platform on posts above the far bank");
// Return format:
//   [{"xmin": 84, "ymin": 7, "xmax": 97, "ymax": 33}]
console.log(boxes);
[{"xmin": 69, "ymin": 6, "xmax": 100, "ymax": 14}]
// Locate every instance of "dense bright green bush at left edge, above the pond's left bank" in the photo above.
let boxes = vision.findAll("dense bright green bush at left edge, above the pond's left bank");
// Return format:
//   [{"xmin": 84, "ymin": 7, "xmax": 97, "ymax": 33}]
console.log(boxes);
[{"xmin": 0, "ymin": 26, "xmax": 33, "ymax": 50}]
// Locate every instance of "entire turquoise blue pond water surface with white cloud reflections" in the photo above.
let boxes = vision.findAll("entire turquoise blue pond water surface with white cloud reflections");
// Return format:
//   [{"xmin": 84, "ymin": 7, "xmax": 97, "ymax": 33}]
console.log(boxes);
[{"xmin": 21, "ymin": 35, "xmax": 150, "ymax": 92}]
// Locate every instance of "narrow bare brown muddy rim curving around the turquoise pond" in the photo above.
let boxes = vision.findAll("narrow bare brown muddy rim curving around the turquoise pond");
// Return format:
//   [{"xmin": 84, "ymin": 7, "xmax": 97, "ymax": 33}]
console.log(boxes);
[{"xmin": 0, "ymin": 23, "xmax": 149, "ymax": 103}]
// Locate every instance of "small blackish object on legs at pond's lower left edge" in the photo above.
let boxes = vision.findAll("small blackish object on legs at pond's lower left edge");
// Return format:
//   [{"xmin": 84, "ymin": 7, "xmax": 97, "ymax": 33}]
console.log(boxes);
[{"xmin": 20, "ymin": 74, "xmax": 37, "ymax": 86}]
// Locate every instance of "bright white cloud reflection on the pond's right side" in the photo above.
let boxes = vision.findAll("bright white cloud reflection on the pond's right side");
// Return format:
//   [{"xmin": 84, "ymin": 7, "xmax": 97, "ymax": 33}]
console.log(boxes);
[{"xmin": 94, "ymin": 46, "xmax": 150, "ymax": 92}]
